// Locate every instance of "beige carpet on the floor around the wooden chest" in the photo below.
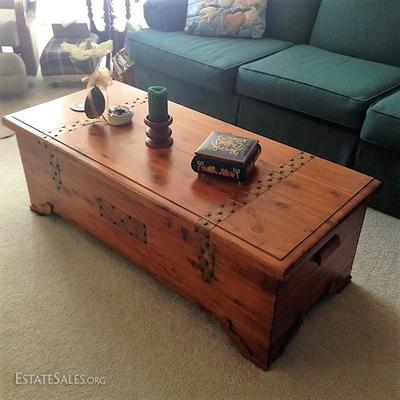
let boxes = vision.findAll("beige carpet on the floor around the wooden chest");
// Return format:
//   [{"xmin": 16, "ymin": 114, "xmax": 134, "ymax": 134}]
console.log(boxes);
[{"xmin": 0, "ymin": 83, "xmax": 400, "ymax": 400}]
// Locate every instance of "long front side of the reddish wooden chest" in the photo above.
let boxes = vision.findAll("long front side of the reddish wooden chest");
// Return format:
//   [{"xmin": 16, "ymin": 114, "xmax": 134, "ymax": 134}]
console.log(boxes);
[{"xmin": 18, "ymin": 135, "xmax": 277, "ymax": 367}]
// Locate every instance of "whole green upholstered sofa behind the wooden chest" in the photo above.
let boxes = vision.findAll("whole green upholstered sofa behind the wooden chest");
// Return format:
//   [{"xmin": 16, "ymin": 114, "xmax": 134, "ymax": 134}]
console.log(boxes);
[{"xmin": 127, "ymin": 0, "xmax": 400, "ymax": 217}]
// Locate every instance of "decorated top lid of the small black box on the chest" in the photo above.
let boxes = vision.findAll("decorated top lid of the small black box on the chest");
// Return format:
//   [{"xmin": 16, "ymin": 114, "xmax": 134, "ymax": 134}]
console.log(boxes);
[{"xmin": 195, "ymin": 132, "xmax": 258, "ymax": 164}]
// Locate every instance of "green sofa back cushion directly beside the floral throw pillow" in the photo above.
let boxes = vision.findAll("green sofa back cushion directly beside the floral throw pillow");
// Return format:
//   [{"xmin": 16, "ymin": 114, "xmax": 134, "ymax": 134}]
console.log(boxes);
[{"xmin": 265, "ymin": 0, "xmax": 321, "ymax": 43}]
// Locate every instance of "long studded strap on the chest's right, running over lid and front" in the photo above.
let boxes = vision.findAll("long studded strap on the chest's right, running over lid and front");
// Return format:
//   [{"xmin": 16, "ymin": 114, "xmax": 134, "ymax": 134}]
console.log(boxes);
[{"xmin": 194, "ymin": 151, "xmax": 313, "ymax": 282}]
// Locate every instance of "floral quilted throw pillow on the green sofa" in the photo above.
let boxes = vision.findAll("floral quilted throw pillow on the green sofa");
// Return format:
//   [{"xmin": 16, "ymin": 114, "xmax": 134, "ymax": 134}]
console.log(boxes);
[{"xmin": 185, "ymin": 0, "xmax": 267, "ymax": 39}]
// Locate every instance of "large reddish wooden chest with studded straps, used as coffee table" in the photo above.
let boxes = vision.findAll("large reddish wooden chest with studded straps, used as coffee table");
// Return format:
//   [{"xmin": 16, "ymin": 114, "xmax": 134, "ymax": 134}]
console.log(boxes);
[{"xmin": 3, "ymin": 83, "xmax": 379, "ymax": 369}]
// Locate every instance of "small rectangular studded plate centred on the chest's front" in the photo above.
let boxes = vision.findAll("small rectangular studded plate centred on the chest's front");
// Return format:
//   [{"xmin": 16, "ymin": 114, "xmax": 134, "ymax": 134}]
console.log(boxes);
[{"xmin": 96, "ymin": 197, "xmax": 147, "ymax": 243}]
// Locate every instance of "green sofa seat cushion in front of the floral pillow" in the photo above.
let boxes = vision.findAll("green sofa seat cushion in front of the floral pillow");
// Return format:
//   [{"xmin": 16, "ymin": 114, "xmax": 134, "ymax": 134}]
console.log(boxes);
[{"xmin": 128, "ymin": 29, "xmax": 291, "ymax": 93}]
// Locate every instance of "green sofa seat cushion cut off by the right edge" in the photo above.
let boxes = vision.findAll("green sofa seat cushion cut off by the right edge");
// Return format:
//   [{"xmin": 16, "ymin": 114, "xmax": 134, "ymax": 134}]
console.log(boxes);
[{"xmin": 361, "ymin": 91, "xmax": 400, "ymax": 152}]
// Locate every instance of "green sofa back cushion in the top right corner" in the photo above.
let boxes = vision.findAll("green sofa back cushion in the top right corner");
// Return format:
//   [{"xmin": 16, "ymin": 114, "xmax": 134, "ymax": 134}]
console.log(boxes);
[{"xmin": 310, "ymin": 0, "xmax": 400, "ymax": 66}]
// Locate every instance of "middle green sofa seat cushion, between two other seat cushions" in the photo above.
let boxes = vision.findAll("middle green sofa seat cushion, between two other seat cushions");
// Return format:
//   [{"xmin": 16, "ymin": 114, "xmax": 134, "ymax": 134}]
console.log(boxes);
[{"xmin": 237, "ymin": 45, "xmax": 400, "ymax": 129}]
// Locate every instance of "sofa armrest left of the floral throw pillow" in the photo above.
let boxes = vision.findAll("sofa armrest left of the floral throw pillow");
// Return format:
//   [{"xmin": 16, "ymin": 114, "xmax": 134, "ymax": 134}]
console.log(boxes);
[{"xmin": 143, "ymin": 0, "xmax": 187, "ymax": 32}]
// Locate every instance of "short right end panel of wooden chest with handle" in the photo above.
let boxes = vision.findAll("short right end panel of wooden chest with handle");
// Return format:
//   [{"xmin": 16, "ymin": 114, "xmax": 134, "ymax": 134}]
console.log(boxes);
[{"xmin": 269, "ymin": 202, "xmax": 366, "ymax": 363}]
